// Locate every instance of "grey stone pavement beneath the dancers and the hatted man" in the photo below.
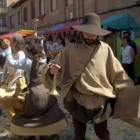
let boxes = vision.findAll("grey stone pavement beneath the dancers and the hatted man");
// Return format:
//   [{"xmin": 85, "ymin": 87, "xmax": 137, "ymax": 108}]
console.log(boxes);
[{"xmin": 0, "ymin": 70, "xmax": 140, "ymax": 140}]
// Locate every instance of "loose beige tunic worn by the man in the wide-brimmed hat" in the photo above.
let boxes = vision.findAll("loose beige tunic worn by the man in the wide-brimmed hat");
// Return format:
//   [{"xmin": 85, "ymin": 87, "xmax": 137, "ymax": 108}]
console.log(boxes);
[{"xmin": 42, "ymin": 42, "xmax": 133, "ymax": 109}]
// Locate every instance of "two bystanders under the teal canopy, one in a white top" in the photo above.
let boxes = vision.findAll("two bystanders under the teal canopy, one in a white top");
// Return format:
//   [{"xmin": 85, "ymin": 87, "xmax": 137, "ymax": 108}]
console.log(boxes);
[{"xmin": 121, "ymin": 31, "xmax": 140, "ymax": 84}]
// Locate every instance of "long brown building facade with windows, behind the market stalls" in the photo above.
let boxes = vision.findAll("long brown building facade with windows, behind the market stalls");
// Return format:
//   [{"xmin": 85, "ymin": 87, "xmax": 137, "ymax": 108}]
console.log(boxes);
[{"xmin": 7, "ymin": 0, "xmax": 140, "ymax": 32}]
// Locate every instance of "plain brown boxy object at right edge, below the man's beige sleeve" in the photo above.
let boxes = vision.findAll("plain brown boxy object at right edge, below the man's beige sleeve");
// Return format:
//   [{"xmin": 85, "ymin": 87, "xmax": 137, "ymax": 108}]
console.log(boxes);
[{"xmin": 113, "ymin": 85, "xmax": 140, "ymax": 119}]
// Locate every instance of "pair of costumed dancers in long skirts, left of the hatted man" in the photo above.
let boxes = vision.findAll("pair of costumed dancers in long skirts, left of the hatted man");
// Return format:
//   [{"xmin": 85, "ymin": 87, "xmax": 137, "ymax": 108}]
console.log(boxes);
[{"xmin": 0, "ymin": 34, "xmax": 67, "ymax": 139}]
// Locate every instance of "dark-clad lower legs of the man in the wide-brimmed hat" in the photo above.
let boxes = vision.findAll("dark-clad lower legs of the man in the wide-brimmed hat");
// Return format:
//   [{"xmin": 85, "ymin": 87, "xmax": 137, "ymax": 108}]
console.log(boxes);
[{"xmin": 73, "ymin": 118, "xmax": 110, "ymax": 140}]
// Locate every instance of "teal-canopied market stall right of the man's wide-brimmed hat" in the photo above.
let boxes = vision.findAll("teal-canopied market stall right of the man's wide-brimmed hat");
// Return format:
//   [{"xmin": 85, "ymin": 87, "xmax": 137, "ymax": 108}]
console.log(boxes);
[{"xmin": 102, "ymin": 13, "xmax": 140, "ymax": 59}]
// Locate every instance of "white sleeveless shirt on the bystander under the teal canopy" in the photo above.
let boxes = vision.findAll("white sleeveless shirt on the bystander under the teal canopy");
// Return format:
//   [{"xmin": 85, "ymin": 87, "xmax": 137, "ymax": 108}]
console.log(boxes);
[{"xmin": 121, "ymin": 45, "xmax": 133, "ymax": 64}]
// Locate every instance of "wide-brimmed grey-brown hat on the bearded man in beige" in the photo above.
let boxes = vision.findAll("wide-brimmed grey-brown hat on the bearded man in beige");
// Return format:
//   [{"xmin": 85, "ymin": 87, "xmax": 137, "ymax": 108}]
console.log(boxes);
[{"xmin": 72, "ymin": 13, "xmax": 111, "ymax": 36}]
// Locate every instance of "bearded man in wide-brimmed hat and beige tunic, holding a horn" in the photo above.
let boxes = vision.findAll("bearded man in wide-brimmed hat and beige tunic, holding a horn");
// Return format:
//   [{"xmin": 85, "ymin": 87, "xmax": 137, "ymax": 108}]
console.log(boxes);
[{"xmin": 42, "ymin": 13, "xmax": 133, "ymax": 140}]
